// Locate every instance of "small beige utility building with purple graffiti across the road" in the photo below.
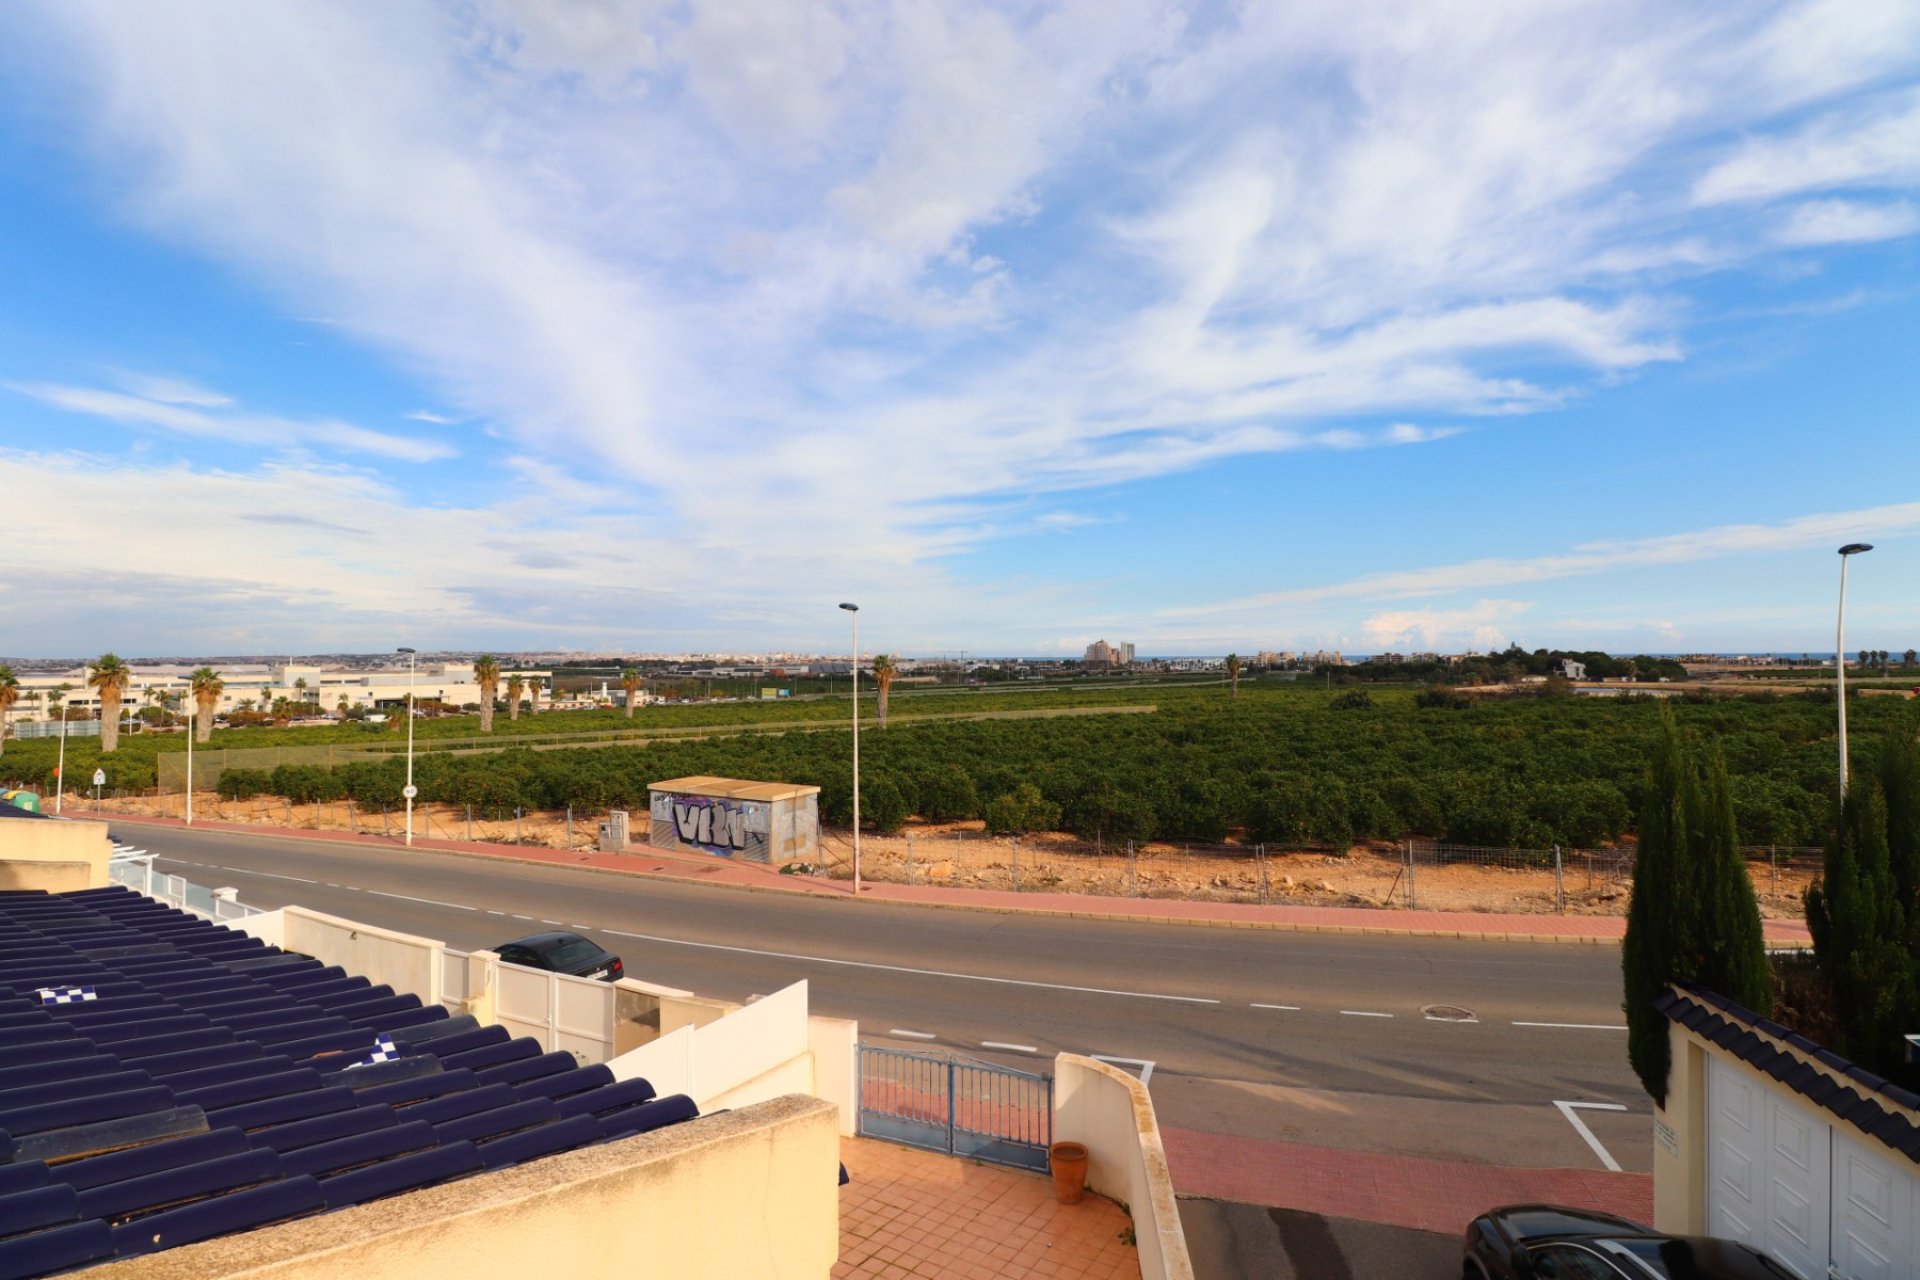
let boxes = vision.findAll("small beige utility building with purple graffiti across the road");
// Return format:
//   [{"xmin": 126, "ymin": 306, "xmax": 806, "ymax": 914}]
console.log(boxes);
[{"xmin": 647, "ymin": 777, "xmax": 820, "ymax": 865}]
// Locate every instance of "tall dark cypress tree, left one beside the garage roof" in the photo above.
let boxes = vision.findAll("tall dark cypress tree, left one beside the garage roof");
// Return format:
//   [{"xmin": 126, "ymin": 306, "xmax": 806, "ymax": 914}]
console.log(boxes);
[{"xmin": 1620, "ymin": 706, "xmax": 1774, "ymax": 1105}]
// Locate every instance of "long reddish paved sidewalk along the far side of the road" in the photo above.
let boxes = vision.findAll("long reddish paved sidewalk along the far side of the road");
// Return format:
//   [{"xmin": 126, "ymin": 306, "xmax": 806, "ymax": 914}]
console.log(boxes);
[{"xmin": 101, "ymin": 812, "xmax": 1812, "ymax": 946}]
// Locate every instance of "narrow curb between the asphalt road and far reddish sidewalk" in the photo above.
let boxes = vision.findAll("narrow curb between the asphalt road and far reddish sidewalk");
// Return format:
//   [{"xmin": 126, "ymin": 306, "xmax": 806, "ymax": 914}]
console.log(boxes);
[{"xmin": 96, "ymin": 814, "xmax": 1812, "ymax": 950}]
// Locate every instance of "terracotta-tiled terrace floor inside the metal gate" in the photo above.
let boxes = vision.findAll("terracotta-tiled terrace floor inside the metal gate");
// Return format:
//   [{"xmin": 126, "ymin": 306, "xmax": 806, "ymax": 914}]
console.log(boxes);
[{"xmin": 833, "ymin": 1138, "xmax": 1140, "ymax": 1280}]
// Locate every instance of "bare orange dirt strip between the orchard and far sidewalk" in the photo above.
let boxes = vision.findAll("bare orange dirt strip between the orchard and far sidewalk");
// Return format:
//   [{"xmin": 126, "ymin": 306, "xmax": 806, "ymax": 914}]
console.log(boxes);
[{"xmin": 106, "ymin": 793, "xmax": 1818, "ymax": 919}]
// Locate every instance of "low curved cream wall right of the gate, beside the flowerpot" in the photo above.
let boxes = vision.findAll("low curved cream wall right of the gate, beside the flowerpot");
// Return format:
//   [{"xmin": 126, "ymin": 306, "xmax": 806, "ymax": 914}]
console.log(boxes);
[{"xmin": 1054, "ymin": 1054, "xmax": 1194, "ymax": 1280}]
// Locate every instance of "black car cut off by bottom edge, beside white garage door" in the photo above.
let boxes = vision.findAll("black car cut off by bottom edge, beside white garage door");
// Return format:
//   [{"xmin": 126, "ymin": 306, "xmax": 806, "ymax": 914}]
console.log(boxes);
[{"xmin": 1459, "ymin": 1205, "xmax": 1793, "ymax": 1280}]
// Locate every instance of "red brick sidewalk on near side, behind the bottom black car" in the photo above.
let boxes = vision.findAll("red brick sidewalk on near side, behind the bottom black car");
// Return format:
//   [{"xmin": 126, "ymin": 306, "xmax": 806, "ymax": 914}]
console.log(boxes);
[{"xmin": 1160, "ymin": 1125, "xmax": 1653, "ymax": 1234}]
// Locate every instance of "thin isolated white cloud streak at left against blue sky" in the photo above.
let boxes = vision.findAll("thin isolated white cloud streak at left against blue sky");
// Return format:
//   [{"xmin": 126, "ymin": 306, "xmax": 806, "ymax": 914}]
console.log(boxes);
[{"xmin": 8, "ymin": 382, "xmax": 455, "ymax": 462}]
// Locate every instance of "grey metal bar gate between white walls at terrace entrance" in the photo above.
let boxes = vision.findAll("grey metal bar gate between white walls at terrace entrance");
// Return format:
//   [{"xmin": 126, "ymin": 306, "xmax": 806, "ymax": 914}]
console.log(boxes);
[{"xmin": 860, "ymin": 1044, "xmax": 1054, "ymax": 1169}]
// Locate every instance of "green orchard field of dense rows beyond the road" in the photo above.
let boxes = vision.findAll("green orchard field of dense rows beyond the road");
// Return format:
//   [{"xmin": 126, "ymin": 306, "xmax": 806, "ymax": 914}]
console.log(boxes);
[{"xmin": 11, "ymin": 681, "xmax": 1914, "ymax": 848}]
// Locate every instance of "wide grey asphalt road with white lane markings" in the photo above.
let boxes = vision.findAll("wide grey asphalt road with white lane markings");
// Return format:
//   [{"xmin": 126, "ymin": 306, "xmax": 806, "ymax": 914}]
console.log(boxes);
[{"xmin": 119, "ymin": 823, "xmax": 1651, "ymax": 1171}]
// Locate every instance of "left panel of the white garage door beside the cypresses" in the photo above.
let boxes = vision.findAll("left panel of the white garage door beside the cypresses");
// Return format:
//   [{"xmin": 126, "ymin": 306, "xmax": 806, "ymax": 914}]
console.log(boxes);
[{"xmin": 1707, "ymin": 1057, "xmax": 1832, "ymax": 1280}]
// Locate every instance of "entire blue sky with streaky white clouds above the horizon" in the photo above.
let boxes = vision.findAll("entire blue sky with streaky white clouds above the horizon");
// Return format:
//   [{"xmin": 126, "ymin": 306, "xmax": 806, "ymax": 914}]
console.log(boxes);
[{"xmin": 0, "ymin": 0, "xmax": 1920, "ymax": 656}]
